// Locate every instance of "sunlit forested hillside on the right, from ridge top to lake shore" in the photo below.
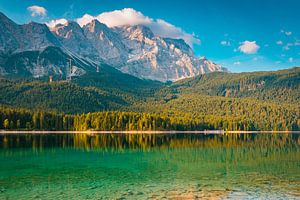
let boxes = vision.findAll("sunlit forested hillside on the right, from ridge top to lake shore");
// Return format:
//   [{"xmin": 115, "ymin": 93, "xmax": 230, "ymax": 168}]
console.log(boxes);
[{"xmin": 127, "ymin": 68, "xmax": 300, "ymax": 130}]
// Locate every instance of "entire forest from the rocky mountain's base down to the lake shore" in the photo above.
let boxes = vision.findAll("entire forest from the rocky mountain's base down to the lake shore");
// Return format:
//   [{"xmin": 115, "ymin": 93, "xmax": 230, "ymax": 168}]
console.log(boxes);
[{"xmin": 0, "ymin": 66, "xmax": 300, "ymax": 130}]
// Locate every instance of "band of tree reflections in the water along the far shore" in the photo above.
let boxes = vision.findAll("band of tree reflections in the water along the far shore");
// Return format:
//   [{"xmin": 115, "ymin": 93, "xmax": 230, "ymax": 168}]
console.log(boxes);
[{"xmin": 0, "ymin": 133, "xmax": 300, "ymax": 151}]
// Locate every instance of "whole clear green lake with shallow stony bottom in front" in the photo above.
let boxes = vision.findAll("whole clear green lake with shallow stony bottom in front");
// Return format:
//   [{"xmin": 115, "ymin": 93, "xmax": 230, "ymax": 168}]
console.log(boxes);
[{"xmin": 0, "ymin": 134, "xmax": 300, "ymax": 199}]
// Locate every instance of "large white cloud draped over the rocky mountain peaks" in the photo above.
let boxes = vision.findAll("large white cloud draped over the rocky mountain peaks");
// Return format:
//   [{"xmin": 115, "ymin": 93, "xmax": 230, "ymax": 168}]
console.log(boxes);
[{"xmin": 76, "ymin": 8, "xmax": 200, "ymax": 46}]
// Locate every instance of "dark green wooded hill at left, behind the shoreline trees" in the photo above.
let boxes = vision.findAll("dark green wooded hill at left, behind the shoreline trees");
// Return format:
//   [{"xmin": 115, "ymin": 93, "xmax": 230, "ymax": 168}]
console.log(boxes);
[{"xmin": 0, "ymin": 79, "xmax": 126, "ymax": 113}]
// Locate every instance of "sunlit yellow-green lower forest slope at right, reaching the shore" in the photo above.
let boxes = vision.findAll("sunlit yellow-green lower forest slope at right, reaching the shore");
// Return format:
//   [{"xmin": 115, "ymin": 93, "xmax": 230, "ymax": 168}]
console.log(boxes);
[{"xmin": 131, "ymin": 94, "xmax": 300, "ymax": 130}]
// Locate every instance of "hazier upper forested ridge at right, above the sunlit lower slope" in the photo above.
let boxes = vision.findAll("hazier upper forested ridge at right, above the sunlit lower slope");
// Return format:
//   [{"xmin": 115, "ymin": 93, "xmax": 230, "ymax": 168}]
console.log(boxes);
[{"xmin": 169, "ymin": 67, "xmax": 300, "ymax": 103}]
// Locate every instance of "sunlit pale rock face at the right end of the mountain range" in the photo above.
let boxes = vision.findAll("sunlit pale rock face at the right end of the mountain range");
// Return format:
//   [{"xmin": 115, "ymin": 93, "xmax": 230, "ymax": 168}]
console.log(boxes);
[{"xmin": 115, "ymin": 25, "xmax": 225, "ymax": 81}]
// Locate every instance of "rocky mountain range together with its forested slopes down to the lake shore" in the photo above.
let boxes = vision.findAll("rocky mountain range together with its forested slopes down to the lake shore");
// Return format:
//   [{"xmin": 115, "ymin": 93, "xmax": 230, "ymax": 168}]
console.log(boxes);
[{"xmin": 0, "ymin": 13, "xmax": 300, "ymax": 130}]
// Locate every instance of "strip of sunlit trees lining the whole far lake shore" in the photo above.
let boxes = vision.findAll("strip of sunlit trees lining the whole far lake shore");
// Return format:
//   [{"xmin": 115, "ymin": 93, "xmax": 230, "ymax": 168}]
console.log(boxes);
[{"xmin": 0, "ymin": 102, "xmax": 300, "ymax": 131}]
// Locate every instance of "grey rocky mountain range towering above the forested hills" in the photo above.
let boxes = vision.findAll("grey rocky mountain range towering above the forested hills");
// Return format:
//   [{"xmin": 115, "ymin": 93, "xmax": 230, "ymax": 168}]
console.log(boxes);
[{"xmin": 0, "ymin": 13, "xmax": 226, "ymax": 82}]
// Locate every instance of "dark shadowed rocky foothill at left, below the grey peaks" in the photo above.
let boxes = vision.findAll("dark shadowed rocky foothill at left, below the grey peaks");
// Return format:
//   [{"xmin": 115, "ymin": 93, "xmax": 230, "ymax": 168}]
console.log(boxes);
[{"xmin": 2, "ymin": 46, "xmax": 91, "ymax": 79}]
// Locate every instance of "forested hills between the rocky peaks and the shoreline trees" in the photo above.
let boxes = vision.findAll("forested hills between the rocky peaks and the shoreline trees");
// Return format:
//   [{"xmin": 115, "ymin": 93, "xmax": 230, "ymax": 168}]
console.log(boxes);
[{"xmin": 0, "ymin": 68, "xmax": 300, "ymax": 114}]
